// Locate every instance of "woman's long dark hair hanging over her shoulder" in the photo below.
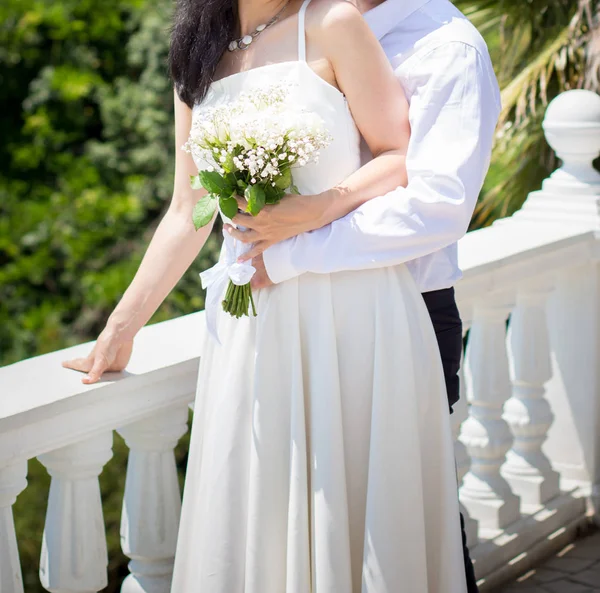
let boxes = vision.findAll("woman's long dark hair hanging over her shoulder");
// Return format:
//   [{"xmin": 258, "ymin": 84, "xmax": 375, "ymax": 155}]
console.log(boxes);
[{"xmin": 169, "ymin": 0, "xmax": 237, "ymax": 107}]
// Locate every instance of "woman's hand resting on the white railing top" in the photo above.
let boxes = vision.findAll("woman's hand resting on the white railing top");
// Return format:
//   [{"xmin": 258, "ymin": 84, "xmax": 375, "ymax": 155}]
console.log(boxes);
[{"xmin": 62, "ymin": 329, "xmax": 133, "ymax": 385}]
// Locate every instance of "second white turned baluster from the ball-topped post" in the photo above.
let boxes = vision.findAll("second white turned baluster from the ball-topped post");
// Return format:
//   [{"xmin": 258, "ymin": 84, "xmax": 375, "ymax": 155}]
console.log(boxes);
[{"xmin": 461, "ymin": 302, "xmax": 519, "ymax": 529}]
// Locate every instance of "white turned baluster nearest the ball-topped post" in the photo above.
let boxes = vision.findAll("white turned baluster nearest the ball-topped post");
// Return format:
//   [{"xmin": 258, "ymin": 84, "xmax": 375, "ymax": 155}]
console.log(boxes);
[{"xmin": 501, "ymin": 286, "xmax": 559, "ymax": 505}]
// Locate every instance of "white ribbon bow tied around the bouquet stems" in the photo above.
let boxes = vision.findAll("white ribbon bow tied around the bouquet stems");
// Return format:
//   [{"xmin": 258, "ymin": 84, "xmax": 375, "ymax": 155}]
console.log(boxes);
[{"xmin": 200, "ymin": 227, "xmax": 256, "ymax": 345}]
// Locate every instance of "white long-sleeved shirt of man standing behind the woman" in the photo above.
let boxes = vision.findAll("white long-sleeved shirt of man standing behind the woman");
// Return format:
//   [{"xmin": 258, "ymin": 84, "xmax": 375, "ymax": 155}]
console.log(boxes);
[{"xmin": 264, "ymin": 0, "xmax": 500, "ymax": 292}]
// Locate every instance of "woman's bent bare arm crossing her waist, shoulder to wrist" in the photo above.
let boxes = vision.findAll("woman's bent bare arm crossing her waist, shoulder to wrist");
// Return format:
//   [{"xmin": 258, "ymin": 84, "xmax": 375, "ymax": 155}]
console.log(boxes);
[{"xmin": 308, "ymin": 0, "xmax": 410, "ymax": 222}]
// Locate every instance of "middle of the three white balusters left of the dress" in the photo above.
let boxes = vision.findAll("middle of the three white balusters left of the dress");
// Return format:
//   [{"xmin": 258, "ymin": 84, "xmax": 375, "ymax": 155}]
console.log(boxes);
[{"xmin": 39, "ymin": 432, "xmax": 112, "ymax": 593}]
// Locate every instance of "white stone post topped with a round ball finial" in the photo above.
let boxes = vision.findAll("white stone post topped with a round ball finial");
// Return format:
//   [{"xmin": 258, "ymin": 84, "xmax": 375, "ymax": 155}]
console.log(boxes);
[{"xmin": 513, "ymin": 90, "xmax": 600, "ymax": 521}]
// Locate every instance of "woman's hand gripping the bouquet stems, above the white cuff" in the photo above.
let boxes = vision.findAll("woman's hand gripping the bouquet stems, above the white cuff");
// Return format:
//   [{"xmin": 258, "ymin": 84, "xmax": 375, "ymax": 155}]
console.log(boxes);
[{"xmin": 225, "ymin": 195, "xmax": 326, "ymax": 262}]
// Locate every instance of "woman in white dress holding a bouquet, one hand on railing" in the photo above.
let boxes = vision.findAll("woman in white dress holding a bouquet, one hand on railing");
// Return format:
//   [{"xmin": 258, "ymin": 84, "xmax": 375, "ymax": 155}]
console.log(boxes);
[{"xmin": 65, "ymin": 0, "xmax": 466, "ymax": 593}]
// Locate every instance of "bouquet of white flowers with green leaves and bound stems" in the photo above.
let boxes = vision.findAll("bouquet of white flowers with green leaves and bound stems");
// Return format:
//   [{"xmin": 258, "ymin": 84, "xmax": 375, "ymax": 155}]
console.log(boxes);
[{"xmin": 183, "ymin": 85, "xmax": 331, "ymax": 328}]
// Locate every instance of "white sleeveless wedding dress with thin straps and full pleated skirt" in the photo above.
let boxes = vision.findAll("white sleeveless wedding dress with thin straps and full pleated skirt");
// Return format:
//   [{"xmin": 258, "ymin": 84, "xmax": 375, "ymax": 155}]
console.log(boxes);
[{"xmin": 172, "ymin": 2, "xmax": 466, "ymax": 593}]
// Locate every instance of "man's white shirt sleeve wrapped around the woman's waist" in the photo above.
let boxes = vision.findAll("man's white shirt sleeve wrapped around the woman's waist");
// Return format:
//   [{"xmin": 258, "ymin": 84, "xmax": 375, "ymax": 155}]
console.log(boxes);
[{"xmin": 264, "ymin": 41, "xmax": 500, "ymax": 283}]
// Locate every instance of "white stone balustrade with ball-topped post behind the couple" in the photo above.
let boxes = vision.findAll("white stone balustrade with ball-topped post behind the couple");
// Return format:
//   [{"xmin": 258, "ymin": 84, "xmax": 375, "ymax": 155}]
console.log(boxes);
[{"xmin": 0, "ymin": 91, "xmax": 600, "ymax": 593}]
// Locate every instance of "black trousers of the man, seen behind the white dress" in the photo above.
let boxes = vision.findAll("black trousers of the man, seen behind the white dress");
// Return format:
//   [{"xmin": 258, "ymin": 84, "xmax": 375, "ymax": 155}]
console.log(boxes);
[{"xmin": 423, "ymin": 288, "xmax": 479, "ymax": 593}]
